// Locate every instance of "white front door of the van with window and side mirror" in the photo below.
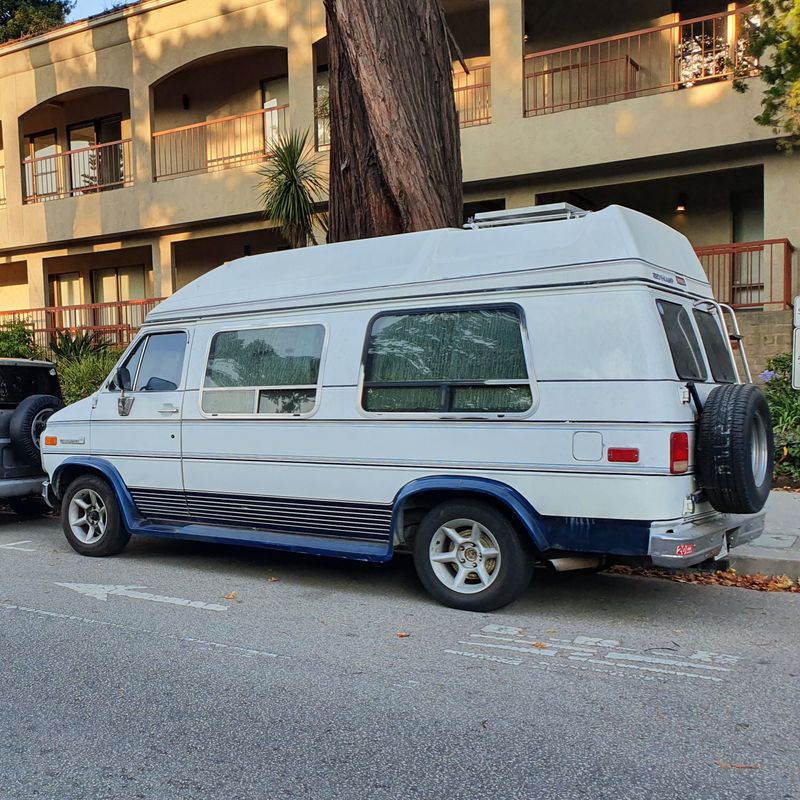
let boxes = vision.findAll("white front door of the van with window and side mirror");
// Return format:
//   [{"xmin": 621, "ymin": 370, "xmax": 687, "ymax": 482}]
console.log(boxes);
[{"xmin": 91, "ymin": 331, "xmax": 189, "ymax": 520}]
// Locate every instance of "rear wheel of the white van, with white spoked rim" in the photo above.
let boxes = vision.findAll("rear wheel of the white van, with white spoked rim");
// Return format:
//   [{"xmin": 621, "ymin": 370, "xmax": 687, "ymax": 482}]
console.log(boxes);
[{"xmin": 414, "ymin": 502, "xmax": 534, "ymax": 611}]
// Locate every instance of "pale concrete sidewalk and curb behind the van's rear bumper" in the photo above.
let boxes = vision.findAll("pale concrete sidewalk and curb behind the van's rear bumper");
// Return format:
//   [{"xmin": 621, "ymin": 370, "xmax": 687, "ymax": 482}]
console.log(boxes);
[{"xmin": 726, "ymin": 492, "xmax": 800, "ymax": 579}]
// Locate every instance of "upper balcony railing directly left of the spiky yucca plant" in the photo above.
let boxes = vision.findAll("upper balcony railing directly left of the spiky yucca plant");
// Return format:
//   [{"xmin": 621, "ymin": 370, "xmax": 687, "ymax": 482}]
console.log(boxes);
[{"xmin": 153, "ymin": 105, "xmax": 289, "ymax": 180}]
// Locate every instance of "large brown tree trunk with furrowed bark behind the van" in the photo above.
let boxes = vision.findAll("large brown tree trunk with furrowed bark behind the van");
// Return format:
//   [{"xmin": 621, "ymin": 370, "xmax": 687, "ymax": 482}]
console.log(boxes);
[{"xmin": 325, "ymin": 0, "xmax": 462, "ymax": 242}]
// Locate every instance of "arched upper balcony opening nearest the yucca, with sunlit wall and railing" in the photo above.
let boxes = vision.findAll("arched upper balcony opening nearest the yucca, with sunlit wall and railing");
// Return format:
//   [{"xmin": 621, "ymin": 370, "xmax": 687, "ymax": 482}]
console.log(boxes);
[{"xmin": 152, "ymin": 47, "xmax": 289, "ymax": 180}]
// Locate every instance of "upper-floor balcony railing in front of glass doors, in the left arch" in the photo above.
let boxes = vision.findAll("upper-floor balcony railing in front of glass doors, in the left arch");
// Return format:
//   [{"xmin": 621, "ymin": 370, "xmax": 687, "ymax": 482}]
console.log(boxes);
[{"xmin": 22, "ymin": 139, "xmax": 133, "ymax": 203}]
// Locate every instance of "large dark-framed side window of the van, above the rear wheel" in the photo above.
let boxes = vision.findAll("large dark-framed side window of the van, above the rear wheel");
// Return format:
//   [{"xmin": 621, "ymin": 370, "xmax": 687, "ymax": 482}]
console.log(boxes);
[{"xmin": 361, "ymin": 307, "xmax": 533, "ymax": 414}]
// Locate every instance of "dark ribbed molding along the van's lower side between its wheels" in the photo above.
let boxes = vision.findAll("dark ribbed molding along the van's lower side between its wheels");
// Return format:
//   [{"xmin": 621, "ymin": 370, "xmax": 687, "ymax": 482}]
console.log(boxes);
[{"xmin": 130, "ymin": 489, "xmax": 392, "ymax": 541}]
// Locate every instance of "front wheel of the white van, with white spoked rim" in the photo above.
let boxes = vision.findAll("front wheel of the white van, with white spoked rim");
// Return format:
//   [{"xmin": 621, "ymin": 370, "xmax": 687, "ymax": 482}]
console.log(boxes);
[{"xmin": 61, "ymin": 475, "xmax": 131, "ymax": 556}]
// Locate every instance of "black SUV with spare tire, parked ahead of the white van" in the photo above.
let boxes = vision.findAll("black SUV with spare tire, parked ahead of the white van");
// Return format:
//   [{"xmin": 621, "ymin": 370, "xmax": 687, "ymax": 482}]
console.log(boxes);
[{"xmin": 0, "ymin": 358, "xmax": 64, "ymax": 516}]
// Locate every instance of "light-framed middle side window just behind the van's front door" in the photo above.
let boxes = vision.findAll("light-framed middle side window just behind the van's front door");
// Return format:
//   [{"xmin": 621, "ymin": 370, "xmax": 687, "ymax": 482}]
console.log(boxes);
[{"xmin": 202, "ymin": 325, "xmax": 325, "ymax": 416}]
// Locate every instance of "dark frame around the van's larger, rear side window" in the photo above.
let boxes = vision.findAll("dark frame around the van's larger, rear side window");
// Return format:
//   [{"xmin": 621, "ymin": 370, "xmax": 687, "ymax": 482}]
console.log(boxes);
[{"xmin": 356, "ymin": 302, "xmax": 540, "ymax": 421}]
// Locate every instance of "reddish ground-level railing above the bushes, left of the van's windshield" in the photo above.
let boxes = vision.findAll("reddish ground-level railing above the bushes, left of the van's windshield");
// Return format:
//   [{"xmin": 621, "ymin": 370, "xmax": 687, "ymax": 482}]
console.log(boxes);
[{"xmin": 0, "ymin": 298, "xmax": 163, "ymax": 350}]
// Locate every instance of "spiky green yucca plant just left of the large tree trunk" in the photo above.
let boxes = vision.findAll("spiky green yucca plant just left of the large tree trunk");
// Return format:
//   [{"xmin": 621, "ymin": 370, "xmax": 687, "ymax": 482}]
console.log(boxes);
[{"xmin": 259, "ymin": 131, "xmax": 327, "ymax": 247}]
